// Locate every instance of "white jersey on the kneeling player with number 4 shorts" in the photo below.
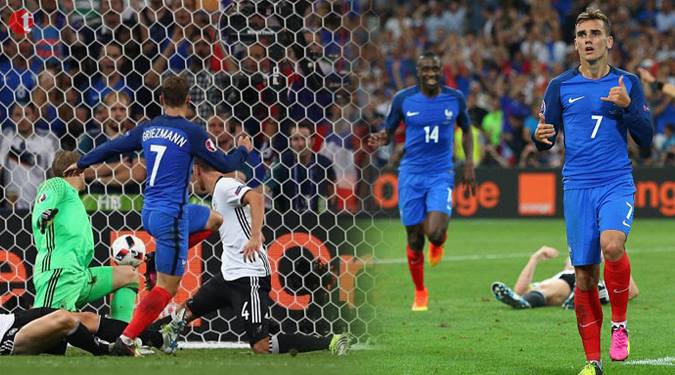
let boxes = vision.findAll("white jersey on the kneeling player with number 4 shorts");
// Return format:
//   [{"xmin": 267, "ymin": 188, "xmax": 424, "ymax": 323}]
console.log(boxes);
[{"xmin": 212, "ymin": 177, "xmax": 270, "ymax": 281}]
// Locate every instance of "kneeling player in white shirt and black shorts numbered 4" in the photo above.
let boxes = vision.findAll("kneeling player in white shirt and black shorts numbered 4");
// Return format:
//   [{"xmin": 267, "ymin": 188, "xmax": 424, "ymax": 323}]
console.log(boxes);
[{"xmin": 162, "ymin": 162, "xmax": 351, "ymax": 355}]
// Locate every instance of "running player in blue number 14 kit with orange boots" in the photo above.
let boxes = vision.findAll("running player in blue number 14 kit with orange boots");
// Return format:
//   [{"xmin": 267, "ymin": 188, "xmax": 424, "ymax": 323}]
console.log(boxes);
[{"xmin": 368, "ymin": 53, "xmax": 476, "ymax": 311}]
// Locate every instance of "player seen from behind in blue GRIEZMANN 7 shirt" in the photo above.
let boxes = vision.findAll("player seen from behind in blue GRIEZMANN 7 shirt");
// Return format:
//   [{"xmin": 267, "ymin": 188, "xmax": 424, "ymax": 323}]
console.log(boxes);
[{"xmin": 67, "ymin": 76, "xmax": 253, "ymax": 355}]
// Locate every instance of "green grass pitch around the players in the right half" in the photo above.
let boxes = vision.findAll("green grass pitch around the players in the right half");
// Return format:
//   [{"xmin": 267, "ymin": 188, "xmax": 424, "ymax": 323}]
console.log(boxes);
[{"xmin": 376, "ymin": 218, "xmax": 675, "ymax": 375}]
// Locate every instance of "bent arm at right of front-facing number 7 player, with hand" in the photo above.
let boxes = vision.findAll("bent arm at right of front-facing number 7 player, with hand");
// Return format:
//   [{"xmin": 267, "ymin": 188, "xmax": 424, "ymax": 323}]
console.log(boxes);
[{"xmin": 601, "ymin": 75, "xmax": 654, "ymax": 147}]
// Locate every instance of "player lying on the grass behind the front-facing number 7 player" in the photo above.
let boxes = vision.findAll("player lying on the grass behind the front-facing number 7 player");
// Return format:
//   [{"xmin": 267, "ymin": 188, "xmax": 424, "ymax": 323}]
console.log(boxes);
[{"xmin": 491, "ymin": 246, "xmax": 638, "ymax": 309}]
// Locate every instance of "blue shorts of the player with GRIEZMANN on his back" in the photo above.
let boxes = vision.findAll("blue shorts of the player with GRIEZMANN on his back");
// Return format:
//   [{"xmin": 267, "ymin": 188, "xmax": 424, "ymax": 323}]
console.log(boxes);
[{"xmin": 142, "ymin": 204, "xmax": 211, "ymax": 276}]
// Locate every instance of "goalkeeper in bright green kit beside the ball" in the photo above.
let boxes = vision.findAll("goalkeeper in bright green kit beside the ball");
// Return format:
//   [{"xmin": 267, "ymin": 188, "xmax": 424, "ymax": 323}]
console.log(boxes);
[{"xmin": 31, "ymin": 151, "xmax": 138, "ymax": 322}]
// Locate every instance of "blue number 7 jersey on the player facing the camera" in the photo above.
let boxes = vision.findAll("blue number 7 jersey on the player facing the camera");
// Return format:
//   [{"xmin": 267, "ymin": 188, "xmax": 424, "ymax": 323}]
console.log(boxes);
[{"xmin": 535, "ymin": 67, "xmax": 653, "ymax": 189}]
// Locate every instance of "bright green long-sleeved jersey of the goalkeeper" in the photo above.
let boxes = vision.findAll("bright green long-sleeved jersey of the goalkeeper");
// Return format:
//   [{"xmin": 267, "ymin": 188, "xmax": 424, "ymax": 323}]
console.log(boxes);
[{"xmin": 31, "ymin": 177, "xmax": 94, "ymax": 274}]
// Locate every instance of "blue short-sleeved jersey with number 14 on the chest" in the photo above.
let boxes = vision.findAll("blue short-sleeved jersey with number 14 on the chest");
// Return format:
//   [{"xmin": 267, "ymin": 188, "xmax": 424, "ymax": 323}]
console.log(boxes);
[{"xmin": 384, "ymin": 86, "xmax": 471, "ymax": 174}]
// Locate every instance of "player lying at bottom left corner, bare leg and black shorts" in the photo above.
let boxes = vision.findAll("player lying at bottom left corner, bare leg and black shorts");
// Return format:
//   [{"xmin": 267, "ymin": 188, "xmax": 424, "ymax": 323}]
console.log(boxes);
[{"xmin": 0, "ymin": 307, "xmax": 165, "ymax": 355}]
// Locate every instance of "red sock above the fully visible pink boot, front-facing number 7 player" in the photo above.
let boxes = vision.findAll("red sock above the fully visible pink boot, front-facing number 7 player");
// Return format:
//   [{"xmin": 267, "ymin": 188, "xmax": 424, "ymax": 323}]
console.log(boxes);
[{"xmin": 605, "ymin": 253, "xmax": 630, "ymax": 323}]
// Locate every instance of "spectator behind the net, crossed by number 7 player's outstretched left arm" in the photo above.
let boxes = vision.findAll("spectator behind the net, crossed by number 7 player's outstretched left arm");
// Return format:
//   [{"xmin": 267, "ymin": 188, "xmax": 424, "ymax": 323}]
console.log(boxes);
[{"xmin": 78, "ymin": 91, "xmax": 145, "ymax": 186}]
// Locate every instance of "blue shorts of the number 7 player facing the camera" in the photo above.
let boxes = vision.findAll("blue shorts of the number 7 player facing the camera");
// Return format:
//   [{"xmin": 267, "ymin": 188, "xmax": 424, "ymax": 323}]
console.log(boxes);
[{"xmin": 563, "ymin": 180, "xmax": 635, "ymax": 266}]
